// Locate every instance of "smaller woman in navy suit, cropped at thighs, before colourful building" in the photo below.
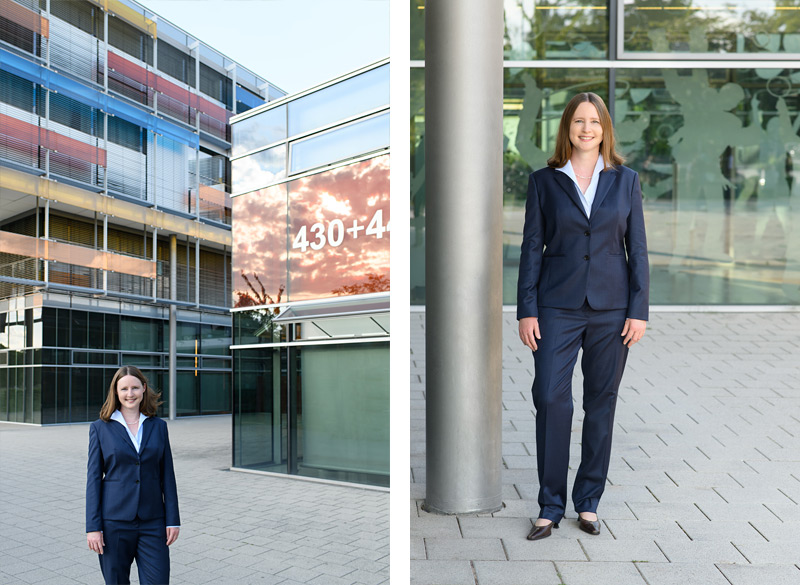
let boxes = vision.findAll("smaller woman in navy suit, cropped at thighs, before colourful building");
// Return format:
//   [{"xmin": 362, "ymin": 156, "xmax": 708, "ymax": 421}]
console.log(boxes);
[{"xmin": 86, "ymin": 366, "xmax": 180, "ymax": 585}]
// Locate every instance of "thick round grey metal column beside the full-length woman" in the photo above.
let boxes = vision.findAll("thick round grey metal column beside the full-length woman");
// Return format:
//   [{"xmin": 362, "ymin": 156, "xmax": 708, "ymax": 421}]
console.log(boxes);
[{"xmin": 425, "ymin": 0, "xmax": 503, "ymax": 514}]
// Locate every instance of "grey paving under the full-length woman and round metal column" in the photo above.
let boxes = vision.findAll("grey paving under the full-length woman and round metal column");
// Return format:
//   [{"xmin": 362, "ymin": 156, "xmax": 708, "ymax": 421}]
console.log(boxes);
[{"xmin": 411, "ymin": 313, "xmax": 800, "ymax": 585}]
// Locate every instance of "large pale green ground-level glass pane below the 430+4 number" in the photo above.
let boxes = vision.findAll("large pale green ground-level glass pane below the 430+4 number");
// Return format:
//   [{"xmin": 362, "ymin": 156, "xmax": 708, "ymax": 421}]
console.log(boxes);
[{"xmin": 296, "ymin": 343, "xmax": 389, "ymax": 485}]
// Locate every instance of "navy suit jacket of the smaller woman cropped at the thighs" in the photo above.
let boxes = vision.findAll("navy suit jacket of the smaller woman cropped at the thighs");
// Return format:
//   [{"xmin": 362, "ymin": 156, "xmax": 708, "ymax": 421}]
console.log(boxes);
[{"xmin": 86, "ymin": 417, "xmax": 181, "ymax": 532}]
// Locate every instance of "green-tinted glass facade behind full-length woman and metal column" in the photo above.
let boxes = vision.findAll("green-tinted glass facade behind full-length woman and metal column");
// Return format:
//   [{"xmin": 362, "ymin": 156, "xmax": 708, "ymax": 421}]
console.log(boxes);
[{"xmin": 411, "ymin": 0, "xmax": 800, "ymax": 306}]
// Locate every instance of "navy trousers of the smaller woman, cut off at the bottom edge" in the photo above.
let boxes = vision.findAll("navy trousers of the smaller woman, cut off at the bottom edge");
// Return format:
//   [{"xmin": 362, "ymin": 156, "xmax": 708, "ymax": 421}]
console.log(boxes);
[{"xmin": 98, "ymin": 517, "xmax": 169, "ymax": 585}]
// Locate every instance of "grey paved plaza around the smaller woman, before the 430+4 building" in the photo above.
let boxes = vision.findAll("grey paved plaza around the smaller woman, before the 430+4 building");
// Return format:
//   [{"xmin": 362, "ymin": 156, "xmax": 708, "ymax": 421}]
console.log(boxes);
[{"xmin": 0, "ymin": 416, "xmax": 389, "ymax": 585}]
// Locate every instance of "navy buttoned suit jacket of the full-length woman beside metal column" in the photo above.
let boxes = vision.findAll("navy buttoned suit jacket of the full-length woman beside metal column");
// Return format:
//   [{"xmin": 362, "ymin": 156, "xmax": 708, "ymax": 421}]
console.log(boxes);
[{"xmin": 517, "ymin": 166, "xmax": 650, "ymax": 320}]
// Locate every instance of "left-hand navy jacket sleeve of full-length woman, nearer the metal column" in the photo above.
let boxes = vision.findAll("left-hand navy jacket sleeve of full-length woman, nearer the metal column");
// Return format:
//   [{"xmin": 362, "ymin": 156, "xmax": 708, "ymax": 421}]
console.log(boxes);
[{"xmin": 517, "ymin": 174, "xmax": 544, "ymax": 320}]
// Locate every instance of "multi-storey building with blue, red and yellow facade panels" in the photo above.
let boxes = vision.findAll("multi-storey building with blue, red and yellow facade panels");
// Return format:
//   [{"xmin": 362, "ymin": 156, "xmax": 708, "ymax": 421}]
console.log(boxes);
[{"xmin": 0, "ymin": 0, "xmax": 285, "ymax": 424}]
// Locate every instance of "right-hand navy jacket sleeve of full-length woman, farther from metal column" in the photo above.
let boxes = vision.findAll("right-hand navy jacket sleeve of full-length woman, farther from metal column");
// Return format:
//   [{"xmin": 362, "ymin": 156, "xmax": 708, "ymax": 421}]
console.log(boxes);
[{"xmin": 625, "ymin": 173, "xmax": 650, "ymax": 321}]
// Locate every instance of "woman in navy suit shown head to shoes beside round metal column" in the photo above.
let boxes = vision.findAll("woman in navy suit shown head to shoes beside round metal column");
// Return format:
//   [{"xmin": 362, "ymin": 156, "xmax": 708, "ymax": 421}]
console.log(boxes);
[{"xmin": 517, "ymin": 93, "xmax": 649, "ymax": 540}]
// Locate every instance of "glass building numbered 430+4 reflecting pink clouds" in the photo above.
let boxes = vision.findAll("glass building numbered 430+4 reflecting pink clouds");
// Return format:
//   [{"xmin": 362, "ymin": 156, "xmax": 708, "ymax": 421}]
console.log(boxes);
[{"xmin": 231, "ymin": 60, "xmax": 391, "ymax": 486}]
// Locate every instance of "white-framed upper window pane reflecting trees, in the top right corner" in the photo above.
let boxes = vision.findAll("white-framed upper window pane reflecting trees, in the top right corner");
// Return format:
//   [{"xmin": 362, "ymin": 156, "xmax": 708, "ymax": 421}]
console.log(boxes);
[{"xmin": 623, "ymin": 0, "xmax": 800, "ymax": 58}]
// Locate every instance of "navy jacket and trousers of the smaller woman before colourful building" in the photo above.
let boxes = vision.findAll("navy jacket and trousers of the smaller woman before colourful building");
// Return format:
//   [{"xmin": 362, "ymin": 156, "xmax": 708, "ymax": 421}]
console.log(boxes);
[{"xmin": 86, "ymin": 416, "xmax": 180, "ymax": 585}]
